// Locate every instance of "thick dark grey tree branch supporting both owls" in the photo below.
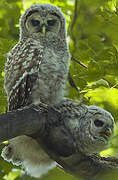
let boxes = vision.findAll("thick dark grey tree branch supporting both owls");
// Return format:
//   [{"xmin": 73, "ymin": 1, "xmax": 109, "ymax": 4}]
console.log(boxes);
[{"xmin": 0, "ymin": 102, "xmax": 118, "ymax": 180}]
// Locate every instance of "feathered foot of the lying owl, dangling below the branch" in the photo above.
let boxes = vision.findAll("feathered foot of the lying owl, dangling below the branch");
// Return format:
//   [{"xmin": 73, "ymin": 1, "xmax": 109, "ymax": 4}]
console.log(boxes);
[{"xmin": 1, "ymin": 144, "xmax": 21, "ymax": 166}]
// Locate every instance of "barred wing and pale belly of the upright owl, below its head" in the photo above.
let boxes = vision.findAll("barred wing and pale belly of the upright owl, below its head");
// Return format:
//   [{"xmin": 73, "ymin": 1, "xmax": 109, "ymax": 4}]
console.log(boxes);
[{"xmin": 4, "ymin": 39, "xmax": 69, "ymax": 110}]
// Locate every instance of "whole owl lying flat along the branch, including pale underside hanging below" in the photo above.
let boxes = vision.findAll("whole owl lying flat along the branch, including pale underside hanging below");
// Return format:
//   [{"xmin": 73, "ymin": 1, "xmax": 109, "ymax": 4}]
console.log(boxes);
[{"xmin": 2, "ymin": 99, "xmax": 114, "ymax": 177}]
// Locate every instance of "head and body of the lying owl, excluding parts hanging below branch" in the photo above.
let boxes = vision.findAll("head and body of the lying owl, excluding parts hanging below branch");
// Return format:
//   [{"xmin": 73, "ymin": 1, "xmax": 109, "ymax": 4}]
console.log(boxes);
[{"xmin": 44, "ymin": 99, "xmax": 114, "ymax": 156}]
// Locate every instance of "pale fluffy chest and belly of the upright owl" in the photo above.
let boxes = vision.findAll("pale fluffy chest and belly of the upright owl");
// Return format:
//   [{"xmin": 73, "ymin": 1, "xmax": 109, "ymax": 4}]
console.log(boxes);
[{"xmin": 32, "ymin": 49, "xmax": 66, "ymax": 104}]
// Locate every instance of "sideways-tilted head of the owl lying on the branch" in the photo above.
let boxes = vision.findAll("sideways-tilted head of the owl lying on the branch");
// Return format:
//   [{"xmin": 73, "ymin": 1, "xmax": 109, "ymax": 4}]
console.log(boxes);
[{"xmin": 78, "ymin": 106, "xmax": 114, "ymax": 155}]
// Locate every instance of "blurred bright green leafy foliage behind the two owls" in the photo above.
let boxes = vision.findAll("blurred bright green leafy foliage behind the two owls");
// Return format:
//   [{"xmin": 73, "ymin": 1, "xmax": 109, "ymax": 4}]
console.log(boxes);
[{"xmin": 0, "ymin": 0, "xmax": 118, "ymax": 180}]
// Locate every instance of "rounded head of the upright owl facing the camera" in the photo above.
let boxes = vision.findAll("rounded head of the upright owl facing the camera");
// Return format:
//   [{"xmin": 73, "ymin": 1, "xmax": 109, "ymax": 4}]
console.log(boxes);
[{"xmin": 20, "ymin": 4, "xmax": 66, "ymax": 39}]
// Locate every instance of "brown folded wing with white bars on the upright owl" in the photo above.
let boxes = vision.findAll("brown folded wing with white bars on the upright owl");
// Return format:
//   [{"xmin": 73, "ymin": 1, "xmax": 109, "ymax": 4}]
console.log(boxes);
[{"xmin": 4, "ymin": 42, "xmax": 41, "ymax": 111}]
